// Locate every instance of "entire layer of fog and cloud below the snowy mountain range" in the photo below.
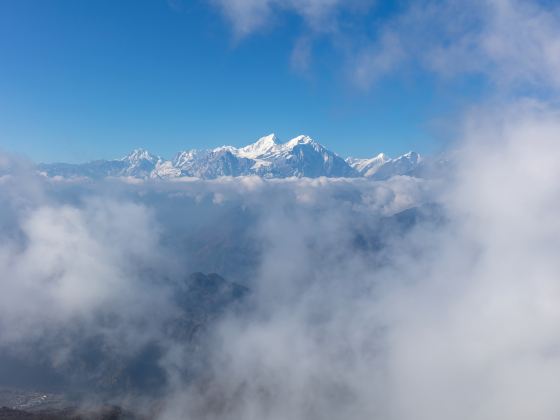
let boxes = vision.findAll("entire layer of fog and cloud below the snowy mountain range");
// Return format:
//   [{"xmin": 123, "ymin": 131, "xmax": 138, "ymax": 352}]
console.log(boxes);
[{"xmin": 0, "ymin": 102, "xmax": 560, "ymax": 420}]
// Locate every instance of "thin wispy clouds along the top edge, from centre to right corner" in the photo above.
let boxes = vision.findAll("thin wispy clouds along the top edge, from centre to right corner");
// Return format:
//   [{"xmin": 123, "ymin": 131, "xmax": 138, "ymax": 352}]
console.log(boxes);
[{"xmin": 208, "ymin": 0, "xmax": 560, "ymax": 90}]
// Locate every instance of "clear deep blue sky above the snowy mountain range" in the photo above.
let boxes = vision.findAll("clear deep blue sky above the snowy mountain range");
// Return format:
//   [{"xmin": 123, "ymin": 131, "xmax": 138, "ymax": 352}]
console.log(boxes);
[{"xmin": 0, "ymin": 0, "xmax": 492, "ymax": 162}]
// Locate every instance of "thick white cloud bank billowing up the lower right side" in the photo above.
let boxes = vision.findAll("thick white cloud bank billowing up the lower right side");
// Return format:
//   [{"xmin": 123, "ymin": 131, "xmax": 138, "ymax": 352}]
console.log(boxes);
[{"xmin": 158, "ymin": 103, "xmax": 560, "ymax": 419}]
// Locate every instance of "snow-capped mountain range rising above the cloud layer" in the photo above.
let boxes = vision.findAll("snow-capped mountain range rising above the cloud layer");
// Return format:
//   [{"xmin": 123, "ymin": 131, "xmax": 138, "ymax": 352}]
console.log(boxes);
[{"xmin": 38, "ymin": 134, "xmax": 420, "ymax": 179}]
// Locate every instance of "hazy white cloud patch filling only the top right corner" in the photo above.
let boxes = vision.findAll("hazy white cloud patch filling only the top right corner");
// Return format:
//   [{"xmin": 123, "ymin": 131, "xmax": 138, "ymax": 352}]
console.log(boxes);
[{"xmin": 356, "ymin": 0, "xmax": 560, "ymax": 91}]
